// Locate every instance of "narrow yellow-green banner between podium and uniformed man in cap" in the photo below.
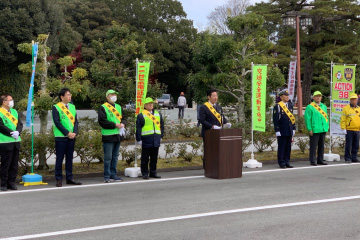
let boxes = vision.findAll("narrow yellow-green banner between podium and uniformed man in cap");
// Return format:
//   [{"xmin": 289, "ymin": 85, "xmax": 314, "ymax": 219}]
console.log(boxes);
[{"xmin": 252, "ymin": 65, "xmax": 267, "ymax": 132}]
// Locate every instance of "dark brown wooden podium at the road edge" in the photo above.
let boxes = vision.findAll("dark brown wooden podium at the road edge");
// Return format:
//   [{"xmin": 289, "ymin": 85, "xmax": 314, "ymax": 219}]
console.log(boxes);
[{"xmin": 204, "ymin": 129, "xmax": 243, "ymax": 179}]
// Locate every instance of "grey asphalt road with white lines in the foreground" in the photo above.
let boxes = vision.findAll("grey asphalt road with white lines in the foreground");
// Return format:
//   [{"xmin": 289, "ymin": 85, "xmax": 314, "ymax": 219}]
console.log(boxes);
[{"xmin": 0, "ymin": 162, "xmax": 360, "ymax": 240}]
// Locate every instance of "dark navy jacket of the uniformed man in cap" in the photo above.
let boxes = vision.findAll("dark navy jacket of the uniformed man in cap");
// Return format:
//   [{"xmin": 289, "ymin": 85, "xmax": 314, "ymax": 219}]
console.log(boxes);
[{"xmin": 273, "ymin": 102, "xmax": 296, "ymax": 136}]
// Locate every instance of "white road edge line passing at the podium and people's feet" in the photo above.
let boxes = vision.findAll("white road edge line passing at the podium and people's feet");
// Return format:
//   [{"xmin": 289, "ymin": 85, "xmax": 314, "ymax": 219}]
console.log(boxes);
[{"xmin": 0, "ymin": 163, "xmax": 357, "ymax": 197}]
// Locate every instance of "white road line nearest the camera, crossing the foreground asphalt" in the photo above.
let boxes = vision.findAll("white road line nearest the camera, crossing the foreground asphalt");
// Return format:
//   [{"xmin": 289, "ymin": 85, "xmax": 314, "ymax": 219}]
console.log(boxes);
[{"xmin": 0, "ymin": 195, "xmax": 360, "ymax": 240}]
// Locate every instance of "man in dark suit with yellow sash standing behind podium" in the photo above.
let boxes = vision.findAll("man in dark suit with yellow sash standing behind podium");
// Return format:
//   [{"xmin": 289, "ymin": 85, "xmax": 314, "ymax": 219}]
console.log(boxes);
[{"xmin": 199, "ymin": 89, "xmax": 231, "ymax": 168}]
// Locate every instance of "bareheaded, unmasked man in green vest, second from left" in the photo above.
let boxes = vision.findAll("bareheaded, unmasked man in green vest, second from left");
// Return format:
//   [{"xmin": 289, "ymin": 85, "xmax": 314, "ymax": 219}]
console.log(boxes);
[{"xmin": 52, "ymin": 88, "xmax": 81, "ymax": 187}]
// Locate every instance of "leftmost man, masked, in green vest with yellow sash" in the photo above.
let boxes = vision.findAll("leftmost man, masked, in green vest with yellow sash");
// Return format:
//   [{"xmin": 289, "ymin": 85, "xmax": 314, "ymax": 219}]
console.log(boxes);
[{"xmin": 0, "ymin": 94, "xmax": 23, "ymax": 191}]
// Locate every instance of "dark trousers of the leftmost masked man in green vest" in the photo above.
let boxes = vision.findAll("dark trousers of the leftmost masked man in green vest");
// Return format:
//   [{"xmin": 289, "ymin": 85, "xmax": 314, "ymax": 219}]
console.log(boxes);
[{"xmin": 0, "ymin": 146, "xmax": 19, "ymax": 187}]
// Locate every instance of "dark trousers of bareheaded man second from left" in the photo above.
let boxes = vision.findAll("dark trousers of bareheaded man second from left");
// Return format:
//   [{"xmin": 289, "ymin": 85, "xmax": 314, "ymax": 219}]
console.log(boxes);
[{"xmin": 55, "ymin": 139, "xmax": 75, "ymax": 181}]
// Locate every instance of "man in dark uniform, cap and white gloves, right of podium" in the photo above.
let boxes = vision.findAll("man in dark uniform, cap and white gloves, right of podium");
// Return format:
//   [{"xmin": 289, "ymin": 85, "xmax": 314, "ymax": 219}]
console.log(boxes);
[{"xmin": 273, "ymin": 89, "xmax": 296, "ymax": 168}]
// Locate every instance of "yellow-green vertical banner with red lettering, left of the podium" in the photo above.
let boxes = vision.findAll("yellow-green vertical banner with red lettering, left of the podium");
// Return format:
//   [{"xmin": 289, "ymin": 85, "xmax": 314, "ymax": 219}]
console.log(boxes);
[{"xmin": 135, "ymin": 62, "xmax": 150, "ymax": 117}]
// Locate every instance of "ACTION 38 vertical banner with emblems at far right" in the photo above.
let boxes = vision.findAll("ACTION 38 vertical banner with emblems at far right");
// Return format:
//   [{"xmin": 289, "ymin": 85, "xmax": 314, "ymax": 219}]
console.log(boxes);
[{"xmin": 330, "ymin": 65, "xmax": 355, "ymax": 135}]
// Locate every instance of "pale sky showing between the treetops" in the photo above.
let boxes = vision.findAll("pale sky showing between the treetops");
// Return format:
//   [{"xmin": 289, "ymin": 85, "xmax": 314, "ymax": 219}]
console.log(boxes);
[{"xmin": 178, "ymin": 0, "xmax": 264, "ymax": 29}]
